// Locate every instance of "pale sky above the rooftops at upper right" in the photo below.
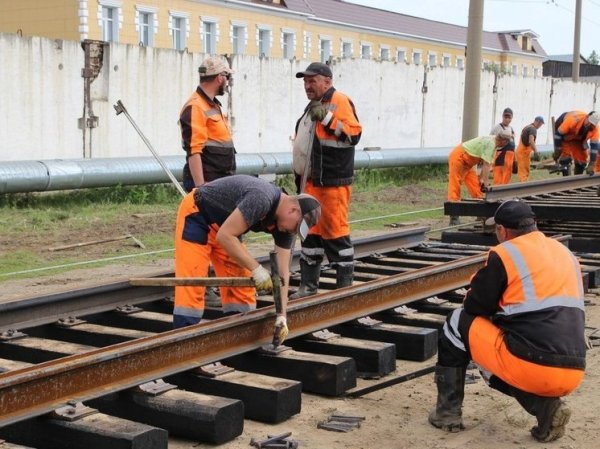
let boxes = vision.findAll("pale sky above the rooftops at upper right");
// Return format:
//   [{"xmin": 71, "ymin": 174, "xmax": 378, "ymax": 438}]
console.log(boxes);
[{"xmin": 344, "ymin": 0, "xmax": 600, "ymax": 58}]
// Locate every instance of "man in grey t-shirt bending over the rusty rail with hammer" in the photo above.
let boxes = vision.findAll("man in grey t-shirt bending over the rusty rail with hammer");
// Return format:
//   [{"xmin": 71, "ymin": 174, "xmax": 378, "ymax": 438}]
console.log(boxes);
[{"xmin": 173, "ymin": 175, "xmax": 321, "ymax": 341}]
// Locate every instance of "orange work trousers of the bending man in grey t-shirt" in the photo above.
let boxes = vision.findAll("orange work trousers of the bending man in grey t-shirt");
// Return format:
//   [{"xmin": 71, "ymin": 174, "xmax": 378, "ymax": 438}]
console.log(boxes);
[{"xmin": 173, "ymin": 190, "xmax": 256, "ymax": 323}]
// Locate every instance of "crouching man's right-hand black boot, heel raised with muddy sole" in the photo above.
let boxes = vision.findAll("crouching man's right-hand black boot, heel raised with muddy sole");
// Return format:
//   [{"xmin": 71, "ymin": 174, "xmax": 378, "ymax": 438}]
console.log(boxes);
[{"xmin": 513, "ymin": 389, "xmax": 571, "ymax": 443}]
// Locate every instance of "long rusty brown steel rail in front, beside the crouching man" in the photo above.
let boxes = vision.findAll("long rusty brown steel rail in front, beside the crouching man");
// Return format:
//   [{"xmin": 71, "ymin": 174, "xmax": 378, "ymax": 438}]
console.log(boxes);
[{"xmin": 0, "ymin": 250, "xmax": 487, "ymax": 426}]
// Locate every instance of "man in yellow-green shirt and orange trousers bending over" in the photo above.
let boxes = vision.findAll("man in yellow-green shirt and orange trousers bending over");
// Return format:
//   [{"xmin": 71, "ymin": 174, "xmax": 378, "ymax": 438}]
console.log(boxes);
[{"xmin": 448, "ymin": 129, "xmax": 512, "ymax": 226}]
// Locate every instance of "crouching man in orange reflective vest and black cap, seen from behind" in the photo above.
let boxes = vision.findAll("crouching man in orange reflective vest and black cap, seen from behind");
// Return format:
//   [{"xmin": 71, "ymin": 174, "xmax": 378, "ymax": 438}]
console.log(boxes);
[{"xmin": 429, "ymin": 200, "xmax": 586, "ymax": 442}]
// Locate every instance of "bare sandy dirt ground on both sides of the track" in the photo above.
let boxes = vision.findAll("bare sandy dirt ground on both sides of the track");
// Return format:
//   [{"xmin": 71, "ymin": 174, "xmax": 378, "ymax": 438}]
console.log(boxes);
[{"xmin": 0, "ymin": 183, "xmax": 600, "ymax": 449}]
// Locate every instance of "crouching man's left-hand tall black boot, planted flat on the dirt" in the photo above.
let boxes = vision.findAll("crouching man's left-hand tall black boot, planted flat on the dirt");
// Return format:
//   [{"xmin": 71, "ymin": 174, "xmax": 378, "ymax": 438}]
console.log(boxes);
[{"xmin": 429, "ymin": 365, "xmax": 466, "ymax": 432}]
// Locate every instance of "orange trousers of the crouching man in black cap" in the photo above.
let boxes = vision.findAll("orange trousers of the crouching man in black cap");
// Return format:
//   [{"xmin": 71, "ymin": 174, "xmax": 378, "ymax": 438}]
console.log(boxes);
[{"xmin": 469, "ymin": 317, "xmax": 584, "ymax": 397}]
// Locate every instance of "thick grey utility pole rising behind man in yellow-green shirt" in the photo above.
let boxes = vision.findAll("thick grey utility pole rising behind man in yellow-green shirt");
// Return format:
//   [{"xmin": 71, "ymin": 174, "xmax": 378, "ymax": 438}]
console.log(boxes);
[{"xmin": 462, "ymin": 0, "xmax": 483, "ymax": 142}]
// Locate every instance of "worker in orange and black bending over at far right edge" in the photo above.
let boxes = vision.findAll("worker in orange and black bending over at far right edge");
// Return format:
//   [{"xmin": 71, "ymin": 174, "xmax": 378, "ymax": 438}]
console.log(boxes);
[{"xmin": 553, "ymin": 111, "xmax": 600, "ymax": 175}]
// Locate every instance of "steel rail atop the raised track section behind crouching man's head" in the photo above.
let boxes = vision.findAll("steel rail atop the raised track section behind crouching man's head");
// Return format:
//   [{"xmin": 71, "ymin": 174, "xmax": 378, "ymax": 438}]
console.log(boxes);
[{"xmin": 484, "ymin": 173, "xmax": 600, "ymax": 202}]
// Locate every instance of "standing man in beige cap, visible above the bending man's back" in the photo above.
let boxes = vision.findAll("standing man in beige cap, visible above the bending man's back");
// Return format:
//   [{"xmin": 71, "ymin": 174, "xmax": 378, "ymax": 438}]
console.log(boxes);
[{"xmin": 179, "ymin": 56, "xmax": 236, "ymax": 192}]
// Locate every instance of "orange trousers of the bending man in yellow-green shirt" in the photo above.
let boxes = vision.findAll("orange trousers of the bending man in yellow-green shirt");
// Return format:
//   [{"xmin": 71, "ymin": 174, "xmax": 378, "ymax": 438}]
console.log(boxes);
[{"xmin": 448, "ymin": 145, "xmax": 483, "ymax": 201}]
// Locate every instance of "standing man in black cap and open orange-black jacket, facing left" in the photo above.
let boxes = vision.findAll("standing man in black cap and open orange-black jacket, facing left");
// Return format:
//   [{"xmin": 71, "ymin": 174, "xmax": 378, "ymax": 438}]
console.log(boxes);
[{"xmin": 291, "ymin": 62, "xmax": 362, "ymax": 299}]
